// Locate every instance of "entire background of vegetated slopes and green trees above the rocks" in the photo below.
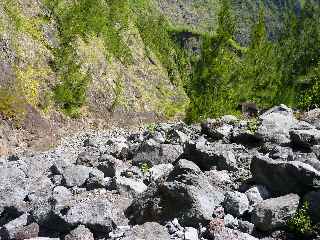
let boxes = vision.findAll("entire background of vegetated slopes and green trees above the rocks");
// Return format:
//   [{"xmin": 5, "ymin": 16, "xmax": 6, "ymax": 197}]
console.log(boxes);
[{"xmin": 0, "ymin": 0, "xmax": 318, "ymax": 129}]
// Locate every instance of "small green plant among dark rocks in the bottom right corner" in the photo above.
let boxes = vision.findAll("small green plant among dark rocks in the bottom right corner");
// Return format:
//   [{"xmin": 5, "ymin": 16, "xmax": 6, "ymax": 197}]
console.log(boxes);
[{"xmin": 287, "ymin": 202, "xmax": 313, "ymax": 236}]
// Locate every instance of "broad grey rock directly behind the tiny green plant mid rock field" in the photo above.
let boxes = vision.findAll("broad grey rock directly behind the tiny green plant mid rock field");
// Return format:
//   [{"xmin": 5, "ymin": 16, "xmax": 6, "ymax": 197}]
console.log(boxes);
[{"xmin": 132, "ymin": 139, "xmax": 183, "ymax": 166}]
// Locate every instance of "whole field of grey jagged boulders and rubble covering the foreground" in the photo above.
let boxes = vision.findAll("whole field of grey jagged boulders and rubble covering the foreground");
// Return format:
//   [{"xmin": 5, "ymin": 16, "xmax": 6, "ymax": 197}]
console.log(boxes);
[{"xmin": 0, "ymin": 105, "xmax": 320, "ymax": 240}]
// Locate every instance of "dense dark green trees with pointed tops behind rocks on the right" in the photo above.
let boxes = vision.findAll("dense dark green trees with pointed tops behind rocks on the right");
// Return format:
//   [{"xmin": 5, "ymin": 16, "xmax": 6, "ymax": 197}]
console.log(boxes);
[{"xmin": 187, "ymin": 1, "xmax": 320, "ymax": 121}]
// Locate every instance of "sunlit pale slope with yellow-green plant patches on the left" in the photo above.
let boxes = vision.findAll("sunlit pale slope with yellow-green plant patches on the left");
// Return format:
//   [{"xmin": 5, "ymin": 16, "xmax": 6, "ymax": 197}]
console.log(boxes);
[{"xmin": 0, "ymin": 0, "xmax": 187, "ymax": 126}]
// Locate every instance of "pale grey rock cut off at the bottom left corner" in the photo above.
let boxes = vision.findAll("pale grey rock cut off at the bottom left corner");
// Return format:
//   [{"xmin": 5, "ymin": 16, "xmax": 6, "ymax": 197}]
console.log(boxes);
[{"xmin": 0, "ymin": 214, "xmax": 29, "ymax": 240}]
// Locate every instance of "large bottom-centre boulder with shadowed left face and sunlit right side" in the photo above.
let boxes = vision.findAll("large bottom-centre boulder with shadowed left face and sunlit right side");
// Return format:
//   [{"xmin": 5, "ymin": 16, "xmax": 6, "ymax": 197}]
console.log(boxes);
[{"xmin": 126, "ymin": 160, "xmax": 223, "ymax": 226}]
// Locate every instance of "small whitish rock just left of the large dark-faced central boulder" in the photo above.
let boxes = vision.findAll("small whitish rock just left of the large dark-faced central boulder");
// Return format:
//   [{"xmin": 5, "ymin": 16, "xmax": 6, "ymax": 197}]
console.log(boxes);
[{"xmin": 116, "ymin": 177, "xmax": 147, "ymax": 197}]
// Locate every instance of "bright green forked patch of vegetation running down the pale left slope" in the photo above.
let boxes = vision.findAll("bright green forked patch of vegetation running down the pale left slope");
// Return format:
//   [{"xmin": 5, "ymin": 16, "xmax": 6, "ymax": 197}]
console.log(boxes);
[{"xmin": 47, "ymin": 0, "xmax": 132, "ymax": 116}]
